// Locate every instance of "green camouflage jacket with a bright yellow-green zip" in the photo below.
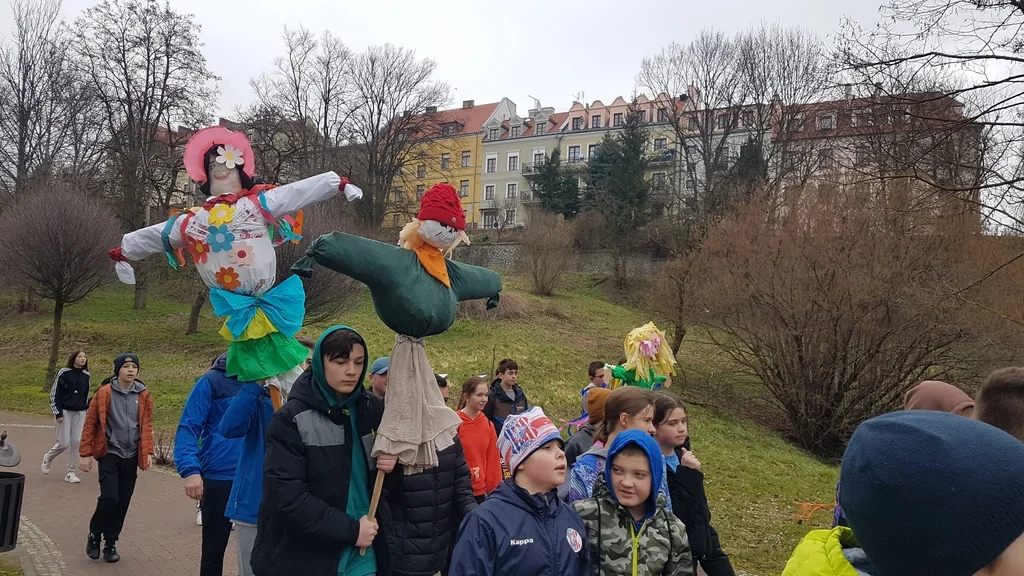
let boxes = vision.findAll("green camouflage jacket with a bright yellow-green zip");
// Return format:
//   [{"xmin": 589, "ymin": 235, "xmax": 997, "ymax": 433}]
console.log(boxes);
[{"xmin": 570, "ymin": 482, "xmax": 694, "ymax": 576}]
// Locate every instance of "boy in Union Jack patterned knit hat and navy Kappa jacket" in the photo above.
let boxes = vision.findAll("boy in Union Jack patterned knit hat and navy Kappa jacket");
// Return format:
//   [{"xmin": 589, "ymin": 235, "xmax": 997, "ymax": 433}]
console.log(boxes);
[{"xmin": 449, "ymin": 408, "xmax": 591, "ymax": 576}]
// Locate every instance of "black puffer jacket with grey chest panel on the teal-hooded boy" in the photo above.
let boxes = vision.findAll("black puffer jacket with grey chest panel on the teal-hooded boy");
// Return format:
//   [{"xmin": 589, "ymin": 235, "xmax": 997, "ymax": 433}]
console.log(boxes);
[{"xmin": 251, "ymin": 370, "xmax": 388, "ymax": 576}]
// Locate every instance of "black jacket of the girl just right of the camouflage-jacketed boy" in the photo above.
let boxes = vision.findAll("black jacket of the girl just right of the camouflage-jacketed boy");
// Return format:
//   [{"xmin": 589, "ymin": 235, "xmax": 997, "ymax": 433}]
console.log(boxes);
[{"xmin": 665, "ymin": 439, "xmax": 735, "ymax": 576}]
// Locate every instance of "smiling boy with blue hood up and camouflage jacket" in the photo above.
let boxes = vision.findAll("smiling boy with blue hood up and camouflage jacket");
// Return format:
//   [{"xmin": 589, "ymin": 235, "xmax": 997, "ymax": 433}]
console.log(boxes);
[{"xmin": 571, "ymin": 429, "xmax": 694, "ymax": 576}]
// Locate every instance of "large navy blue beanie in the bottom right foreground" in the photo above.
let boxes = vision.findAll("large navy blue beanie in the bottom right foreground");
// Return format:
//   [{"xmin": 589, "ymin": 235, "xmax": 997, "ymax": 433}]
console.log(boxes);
[{"xmin": 839, "ymin": 410, "xmax": 1024, "ymax": 576}]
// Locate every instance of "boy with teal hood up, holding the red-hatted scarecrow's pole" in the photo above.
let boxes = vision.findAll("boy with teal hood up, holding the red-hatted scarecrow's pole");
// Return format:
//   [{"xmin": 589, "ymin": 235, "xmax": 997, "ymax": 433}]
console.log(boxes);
[{"xmin": 251, "ymin": 326, "xmax": 396, "ymax": 576}]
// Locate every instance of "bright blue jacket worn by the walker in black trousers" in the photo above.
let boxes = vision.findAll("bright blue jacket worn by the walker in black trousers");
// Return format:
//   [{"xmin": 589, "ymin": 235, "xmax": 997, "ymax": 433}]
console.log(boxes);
[{"xmin": 174, "ymin": 355, "xmax": 244, "ymax": 481}]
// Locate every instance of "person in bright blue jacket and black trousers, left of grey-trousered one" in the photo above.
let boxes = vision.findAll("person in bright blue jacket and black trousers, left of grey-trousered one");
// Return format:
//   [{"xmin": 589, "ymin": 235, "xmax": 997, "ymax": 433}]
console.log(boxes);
[{"xmin": 174, "ymin": 354, "xmax": 244, "ymax": 576}]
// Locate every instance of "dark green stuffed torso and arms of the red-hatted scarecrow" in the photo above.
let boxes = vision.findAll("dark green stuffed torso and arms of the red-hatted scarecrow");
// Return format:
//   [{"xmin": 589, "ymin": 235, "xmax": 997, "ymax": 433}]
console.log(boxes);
[{"xmin": 292, "ymin": 232, "xmax": 502, "ymax": 338}]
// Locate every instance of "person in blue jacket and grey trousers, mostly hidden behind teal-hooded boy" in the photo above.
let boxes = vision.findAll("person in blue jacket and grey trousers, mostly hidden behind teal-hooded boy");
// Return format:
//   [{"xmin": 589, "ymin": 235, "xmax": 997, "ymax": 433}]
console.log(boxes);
[{"xmin": 219, "ymin": 336, "xmax": 313, "ymax": 576}]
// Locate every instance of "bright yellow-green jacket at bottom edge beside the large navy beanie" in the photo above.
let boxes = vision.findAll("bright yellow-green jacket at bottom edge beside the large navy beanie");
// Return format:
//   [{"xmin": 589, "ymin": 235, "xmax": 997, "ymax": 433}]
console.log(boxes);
[{"xmin": 782, "ymin": 526, "xmax": 870, "ymax": 576}]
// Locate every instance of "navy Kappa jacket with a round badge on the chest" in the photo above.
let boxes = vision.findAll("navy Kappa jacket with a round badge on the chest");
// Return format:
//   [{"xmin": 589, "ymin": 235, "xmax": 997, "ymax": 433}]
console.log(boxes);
[{"xmin": 449, "ymin": 480, "xmax": 591, "ymax": 576}]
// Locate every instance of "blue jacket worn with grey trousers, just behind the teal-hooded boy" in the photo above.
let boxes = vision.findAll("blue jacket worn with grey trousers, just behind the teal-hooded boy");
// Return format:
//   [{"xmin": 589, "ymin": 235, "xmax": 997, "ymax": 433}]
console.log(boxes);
[{"xmin": 217, "ymin": 383, "xmax": 273, "ymax": 524}]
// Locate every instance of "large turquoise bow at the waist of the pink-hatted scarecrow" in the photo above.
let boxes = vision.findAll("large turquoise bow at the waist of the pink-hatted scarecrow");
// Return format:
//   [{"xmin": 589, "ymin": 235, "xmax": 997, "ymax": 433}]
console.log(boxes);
[{"xmin": 210, "ymin": 276, "xmax": 306, "ymax": 339}]
